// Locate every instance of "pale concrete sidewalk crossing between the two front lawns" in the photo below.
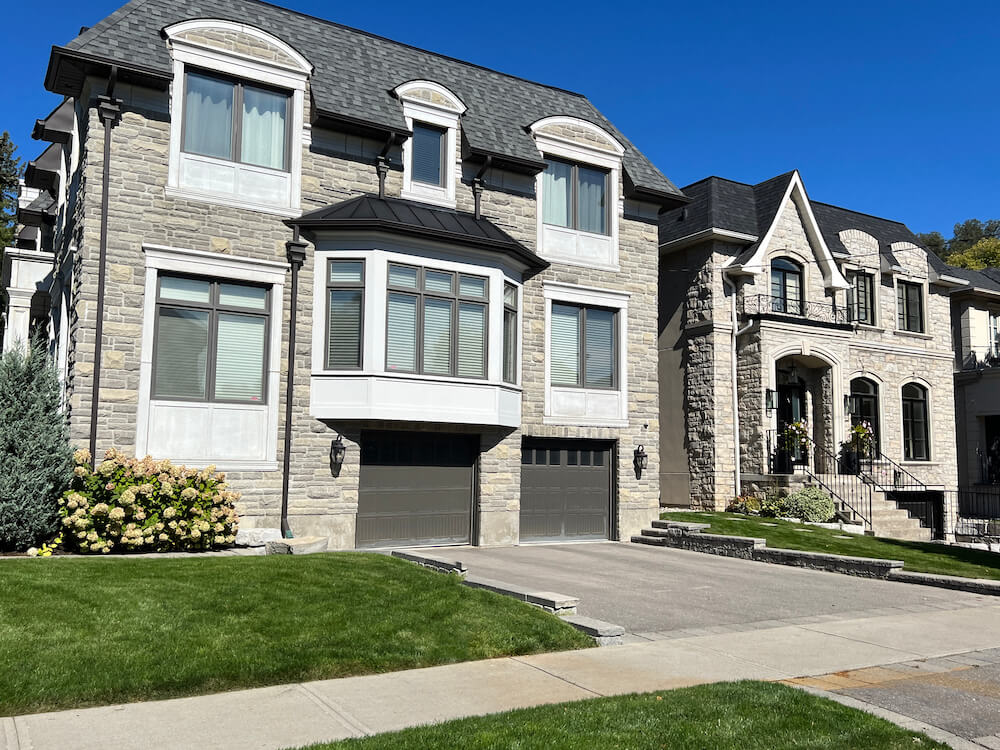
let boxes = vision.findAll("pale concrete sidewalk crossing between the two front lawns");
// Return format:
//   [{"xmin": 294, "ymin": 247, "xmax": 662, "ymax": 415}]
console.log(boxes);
[{"xmin": 7, "ymin": 605, "xmax": 1000, "ymax": 750}]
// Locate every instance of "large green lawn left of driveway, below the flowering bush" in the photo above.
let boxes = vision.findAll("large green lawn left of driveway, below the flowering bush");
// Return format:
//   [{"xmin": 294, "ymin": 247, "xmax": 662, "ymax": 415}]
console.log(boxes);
[{"xmin": 0, "ymin": 552, "xmax": 593, "ymax": 716}]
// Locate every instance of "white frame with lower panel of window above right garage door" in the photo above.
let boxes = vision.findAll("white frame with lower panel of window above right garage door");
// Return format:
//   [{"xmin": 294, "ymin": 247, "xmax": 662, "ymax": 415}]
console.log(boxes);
[{"xmin": 542, "ymin": 281, "xmax": 630, "ymax": 427}]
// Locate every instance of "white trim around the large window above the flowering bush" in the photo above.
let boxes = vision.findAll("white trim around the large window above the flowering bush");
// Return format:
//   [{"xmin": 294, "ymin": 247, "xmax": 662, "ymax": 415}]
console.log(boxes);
[{"xmin": 135, "ymin": 244, "xmax": 289, "ymax": 471}]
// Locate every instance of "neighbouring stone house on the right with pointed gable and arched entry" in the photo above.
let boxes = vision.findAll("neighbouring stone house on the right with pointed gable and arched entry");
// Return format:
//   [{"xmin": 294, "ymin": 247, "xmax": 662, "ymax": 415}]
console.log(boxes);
[{"xmin": 659, "ymin": 172, "xmax": 965, "ymax": 538}]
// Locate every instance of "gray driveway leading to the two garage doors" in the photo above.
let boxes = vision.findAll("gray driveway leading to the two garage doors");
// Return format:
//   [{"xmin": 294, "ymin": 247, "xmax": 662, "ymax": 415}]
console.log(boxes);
[{"xmin": 425, "ymin": 542, "xmax": 997, "ymax": 640}]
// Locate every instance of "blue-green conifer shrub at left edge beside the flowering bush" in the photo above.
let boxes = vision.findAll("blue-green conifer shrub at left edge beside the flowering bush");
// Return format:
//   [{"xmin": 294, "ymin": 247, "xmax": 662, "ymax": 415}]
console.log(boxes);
[{"xmin": 0, "ymin": 340, "xmax": 73, "ymax": 550}]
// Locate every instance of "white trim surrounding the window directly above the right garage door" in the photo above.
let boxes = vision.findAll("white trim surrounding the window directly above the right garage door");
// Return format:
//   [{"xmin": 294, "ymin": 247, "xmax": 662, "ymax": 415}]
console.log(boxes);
[{"xmin": 542, "ymin": 281, "xmax": 631, "ymax": 427}]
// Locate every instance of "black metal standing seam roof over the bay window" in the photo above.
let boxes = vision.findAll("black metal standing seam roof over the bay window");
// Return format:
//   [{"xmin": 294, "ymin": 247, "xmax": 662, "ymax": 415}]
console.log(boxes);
[{"xmin": 285, "ymin": 195, "xmax": 549, "ymax": 271}]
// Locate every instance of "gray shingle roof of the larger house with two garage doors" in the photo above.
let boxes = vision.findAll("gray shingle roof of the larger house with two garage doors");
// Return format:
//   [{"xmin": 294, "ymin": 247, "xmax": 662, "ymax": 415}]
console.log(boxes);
[{"xmin": 46, "ymin": 0, "xmax": 683, "ymax": 200}]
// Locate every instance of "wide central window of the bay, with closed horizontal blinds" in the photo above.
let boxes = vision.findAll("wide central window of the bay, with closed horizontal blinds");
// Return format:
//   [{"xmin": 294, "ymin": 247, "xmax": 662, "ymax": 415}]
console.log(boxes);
[{"xmin": 386, "ymin": 263, "xmax": 489, "ymax": 378}]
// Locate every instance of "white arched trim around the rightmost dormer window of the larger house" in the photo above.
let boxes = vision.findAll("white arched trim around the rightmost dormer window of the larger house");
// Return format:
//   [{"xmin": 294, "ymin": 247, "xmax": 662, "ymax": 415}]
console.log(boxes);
[{"xmin": 531, "ymin": 122, "xmax": 625, "ymax": 271}]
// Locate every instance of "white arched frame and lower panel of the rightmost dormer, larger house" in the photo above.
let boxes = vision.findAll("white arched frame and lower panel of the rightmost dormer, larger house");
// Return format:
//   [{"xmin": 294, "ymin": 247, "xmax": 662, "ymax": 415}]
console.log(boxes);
[{"xmin": 531, "ymin": 117, "xmax": 625, "ymax": 271}]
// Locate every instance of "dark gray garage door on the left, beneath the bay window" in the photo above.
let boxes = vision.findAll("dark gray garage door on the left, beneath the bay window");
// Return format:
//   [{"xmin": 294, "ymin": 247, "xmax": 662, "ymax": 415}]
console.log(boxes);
[{"xmin": 357, "ymin": 431, "xmax": 479, "ymax": 547}]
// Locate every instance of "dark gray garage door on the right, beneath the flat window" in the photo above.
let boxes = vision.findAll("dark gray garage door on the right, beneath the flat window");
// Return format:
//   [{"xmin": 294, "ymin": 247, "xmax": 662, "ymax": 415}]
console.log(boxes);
[{"xmin": 521, "ymin": 438, "xmax": 612, "ymax": 542}]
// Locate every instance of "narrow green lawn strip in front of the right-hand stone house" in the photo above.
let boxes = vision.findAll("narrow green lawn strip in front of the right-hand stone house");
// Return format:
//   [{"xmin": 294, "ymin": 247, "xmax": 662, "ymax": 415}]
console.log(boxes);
[{"xmin": 661, "ymin": 511, "xmax": 1000, "ymax": 580}]
